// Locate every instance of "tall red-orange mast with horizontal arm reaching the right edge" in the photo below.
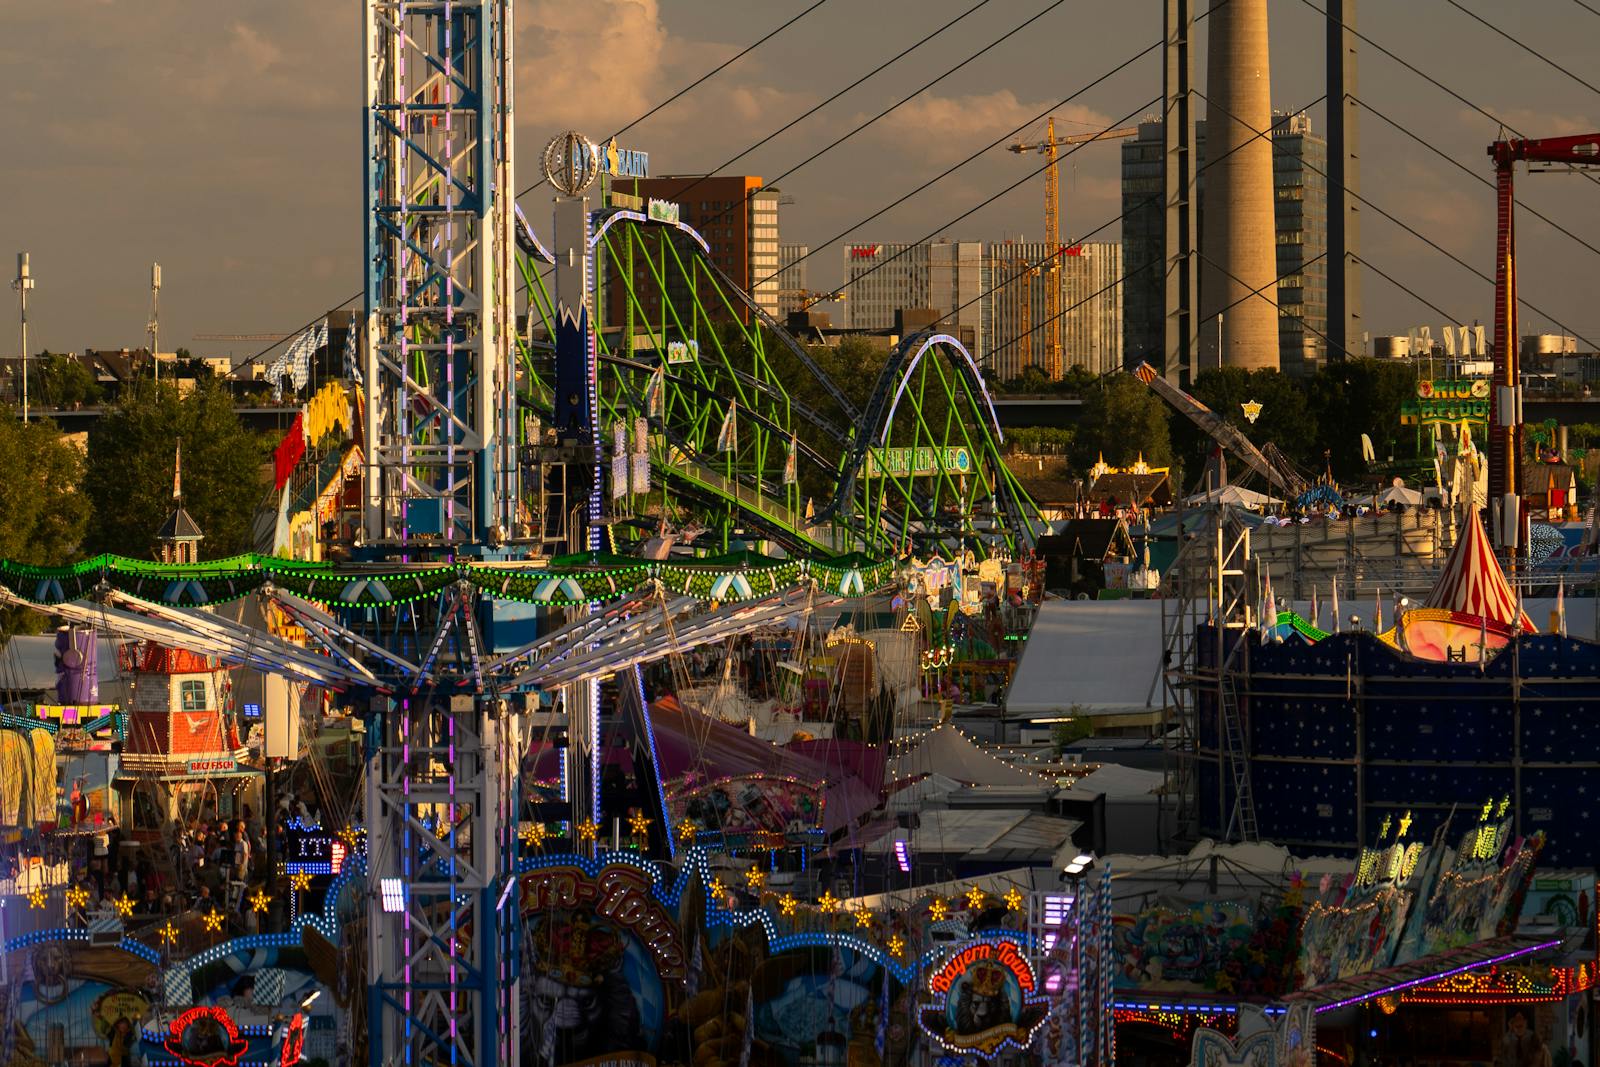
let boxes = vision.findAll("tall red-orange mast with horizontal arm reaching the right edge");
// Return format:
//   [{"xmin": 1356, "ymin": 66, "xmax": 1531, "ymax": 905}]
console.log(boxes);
[{"xmin": 1488, "ymin": 133, "xmax": 1600, "ymax": 558}]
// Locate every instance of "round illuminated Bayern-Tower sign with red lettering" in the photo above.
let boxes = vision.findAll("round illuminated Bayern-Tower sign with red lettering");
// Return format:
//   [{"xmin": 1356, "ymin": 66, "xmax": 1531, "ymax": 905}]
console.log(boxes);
[{"xmin": 920, "ymin": 939, "xmax": 1048, "ymax": 1056}]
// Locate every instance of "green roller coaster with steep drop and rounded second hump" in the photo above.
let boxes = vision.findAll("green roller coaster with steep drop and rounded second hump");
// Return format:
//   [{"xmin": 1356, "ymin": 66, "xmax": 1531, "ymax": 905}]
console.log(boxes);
[{"xmin": 518, "ymin": 210, "xmax": 1045, "ymax": 555}]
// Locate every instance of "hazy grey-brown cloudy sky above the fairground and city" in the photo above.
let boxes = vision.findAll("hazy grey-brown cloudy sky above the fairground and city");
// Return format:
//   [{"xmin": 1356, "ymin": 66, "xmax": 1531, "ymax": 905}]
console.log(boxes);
[{"xmin": 0, "ymin": 0, "xmax": 1600, "ymax": 357}]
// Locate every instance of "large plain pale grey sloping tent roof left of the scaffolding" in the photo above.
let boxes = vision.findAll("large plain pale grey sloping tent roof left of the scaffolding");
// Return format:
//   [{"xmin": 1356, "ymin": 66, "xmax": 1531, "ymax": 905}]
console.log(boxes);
[{"xmin": 1005, "ymin": 600, "xmax": 1162, "ymax": 715}]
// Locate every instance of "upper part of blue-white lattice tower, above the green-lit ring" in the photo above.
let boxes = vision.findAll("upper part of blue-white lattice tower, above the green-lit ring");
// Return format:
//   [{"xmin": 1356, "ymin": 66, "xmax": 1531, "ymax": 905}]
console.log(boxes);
[{"xmin": 362, "ymin": 0, "xmax": 517, "ymax": 544}]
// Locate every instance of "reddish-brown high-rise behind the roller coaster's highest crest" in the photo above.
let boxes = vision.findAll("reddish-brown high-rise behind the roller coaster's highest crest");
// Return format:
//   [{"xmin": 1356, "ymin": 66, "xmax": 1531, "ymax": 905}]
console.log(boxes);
[{"xmin": 605, "ymin": 174, "xmax": 779, "ymax": 326}]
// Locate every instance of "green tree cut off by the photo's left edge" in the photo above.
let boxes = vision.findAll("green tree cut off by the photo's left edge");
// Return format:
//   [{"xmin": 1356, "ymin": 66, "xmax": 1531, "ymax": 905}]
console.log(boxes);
[{"xmin": 0, "ymin": 408, "xmax": 90, "ymax": 633}]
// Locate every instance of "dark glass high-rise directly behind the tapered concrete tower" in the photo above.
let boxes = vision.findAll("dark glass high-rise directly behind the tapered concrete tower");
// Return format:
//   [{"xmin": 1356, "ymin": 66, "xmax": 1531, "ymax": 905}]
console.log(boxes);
[{"xmin": 1122, "ymin": 114, "xmax": 1328, "ymax": 374}]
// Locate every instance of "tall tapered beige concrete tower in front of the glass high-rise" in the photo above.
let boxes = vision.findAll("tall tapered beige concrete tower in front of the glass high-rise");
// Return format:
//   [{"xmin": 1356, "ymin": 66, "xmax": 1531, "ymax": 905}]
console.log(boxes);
[{"xmin": 1198, "ymin": 0, "xmax": 1278, "ymax": 370}]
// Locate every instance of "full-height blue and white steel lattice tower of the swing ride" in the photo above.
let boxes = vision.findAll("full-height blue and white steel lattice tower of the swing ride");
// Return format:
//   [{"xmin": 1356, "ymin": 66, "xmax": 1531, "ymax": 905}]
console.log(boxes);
[{"xmin": 358, "ymin": 0, "xmax": 518, "ymax": 1067}]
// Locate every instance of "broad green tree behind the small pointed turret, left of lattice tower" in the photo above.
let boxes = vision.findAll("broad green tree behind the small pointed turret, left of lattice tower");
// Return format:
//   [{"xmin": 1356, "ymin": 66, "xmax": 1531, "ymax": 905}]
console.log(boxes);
[{"xmin": 83, "ymin": 381, "xmax": 269, "ymax": 558}]
